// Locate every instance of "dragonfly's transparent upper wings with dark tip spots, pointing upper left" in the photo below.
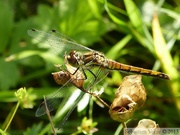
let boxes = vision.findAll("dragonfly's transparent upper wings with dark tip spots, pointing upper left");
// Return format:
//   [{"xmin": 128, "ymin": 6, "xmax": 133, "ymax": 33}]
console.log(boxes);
[{"xmin": 27, "ymin": 29, "xmax": 93, "ymax": 56}]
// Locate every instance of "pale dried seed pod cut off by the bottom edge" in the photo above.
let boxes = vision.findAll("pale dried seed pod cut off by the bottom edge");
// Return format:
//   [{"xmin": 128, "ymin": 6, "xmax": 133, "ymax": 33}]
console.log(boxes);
[{"xmin": 131, "ymin": 119, "xmax": 160, "ymax": 135}]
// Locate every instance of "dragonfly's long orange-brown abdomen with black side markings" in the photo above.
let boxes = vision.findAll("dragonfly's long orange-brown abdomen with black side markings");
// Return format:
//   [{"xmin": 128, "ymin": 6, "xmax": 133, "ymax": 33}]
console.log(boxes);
[{"xmin": 107, "ymin": 60, "xmax": 170, "ymax": 80}]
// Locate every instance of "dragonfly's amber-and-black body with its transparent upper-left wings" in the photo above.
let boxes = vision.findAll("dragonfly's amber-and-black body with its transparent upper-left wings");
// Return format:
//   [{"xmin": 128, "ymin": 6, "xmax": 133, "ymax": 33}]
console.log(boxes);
[{"xmin": 28, "ymin": 29, "xmax": 170, "ymax": 80}]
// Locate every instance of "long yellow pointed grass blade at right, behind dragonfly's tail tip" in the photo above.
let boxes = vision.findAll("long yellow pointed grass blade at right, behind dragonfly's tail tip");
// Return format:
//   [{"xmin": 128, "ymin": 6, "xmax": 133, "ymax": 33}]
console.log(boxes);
[{"xmin": 152, "ymin": 14, "xmax": 180, "ymax": 110}]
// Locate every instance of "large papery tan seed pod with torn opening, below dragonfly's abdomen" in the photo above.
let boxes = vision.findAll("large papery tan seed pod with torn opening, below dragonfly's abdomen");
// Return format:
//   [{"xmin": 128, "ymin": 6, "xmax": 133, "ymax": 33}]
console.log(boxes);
[{"xmin": 109, "ymin": 75, "xmax": 146, "ymax": 122}]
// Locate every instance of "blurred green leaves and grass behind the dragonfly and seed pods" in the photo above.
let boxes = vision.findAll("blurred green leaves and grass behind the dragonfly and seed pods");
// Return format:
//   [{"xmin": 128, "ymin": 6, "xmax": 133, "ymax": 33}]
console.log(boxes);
[{"xmin": 0, "ymin": 0, "xmax": 180, "ymax": 135}]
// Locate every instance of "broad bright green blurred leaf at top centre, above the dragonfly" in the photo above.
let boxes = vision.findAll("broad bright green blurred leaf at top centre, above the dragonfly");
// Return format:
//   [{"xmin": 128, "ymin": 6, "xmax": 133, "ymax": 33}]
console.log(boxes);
[{"xmin": 57, "ymin": 0, "xmax": 109, "ymax": 44}]
